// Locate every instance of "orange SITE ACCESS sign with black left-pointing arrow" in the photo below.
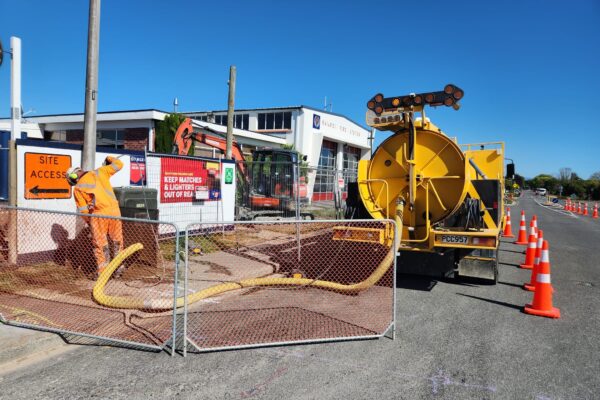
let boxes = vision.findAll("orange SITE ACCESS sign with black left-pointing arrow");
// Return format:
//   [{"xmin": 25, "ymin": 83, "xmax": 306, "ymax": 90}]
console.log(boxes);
[{"xmin": 25, "ymin": 153, "xmax": 71, "ymax": 199}]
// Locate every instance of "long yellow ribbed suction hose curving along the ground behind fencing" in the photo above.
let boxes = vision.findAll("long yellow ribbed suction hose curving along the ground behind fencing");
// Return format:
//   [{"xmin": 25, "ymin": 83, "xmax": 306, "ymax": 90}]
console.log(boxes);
[{"xmin": 93, "ymin": 214, "xmax": 402, "ymax": 310}]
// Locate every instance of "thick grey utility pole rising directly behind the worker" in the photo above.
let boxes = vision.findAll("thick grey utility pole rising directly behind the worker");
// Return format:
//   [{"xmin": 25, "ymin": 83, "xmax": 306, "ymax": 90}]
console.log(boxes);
[{"xmin": 81, "ymin": 0, "xmax": 100, "ymax": 171}]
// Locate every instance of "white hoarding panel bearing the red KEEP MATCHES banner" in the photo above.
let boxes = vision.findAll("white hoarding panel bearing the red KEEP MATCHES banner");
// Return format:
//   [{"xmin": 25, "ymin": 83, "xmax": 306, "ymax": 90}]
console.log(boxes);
[{"xmin": 146, "ymin": 153, "xmax": 236, "ymax": 234}]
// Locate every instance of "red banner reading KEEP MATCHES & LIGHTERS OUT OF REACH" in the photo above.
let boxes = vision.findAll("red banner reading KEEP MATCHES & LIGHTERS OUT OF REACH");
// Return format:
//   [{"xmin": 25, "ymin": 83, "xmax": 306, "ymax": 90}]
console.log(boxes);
[{"xmin": 160, "ymin": 157, "xmax": 208, "ymax": 203}]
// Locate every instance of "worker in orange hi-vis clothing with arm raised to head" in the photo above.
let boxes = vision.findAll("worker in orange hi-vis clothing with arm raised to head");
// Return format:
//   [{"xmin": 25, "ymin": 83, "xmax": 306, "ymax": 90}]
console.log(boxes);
[{"xmin": 67, "ymin": 156, "xmax": 123, "ymax": 275}]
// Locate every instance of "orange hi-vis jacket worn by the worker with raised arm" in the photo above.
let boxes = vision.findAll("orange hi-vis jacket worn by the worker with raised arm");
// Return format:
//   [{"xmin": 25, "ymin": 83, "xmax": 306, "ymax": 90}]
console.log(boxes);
[{"xmin": 73, "ymin": 157, "xmax": 123, "ymax": 216}]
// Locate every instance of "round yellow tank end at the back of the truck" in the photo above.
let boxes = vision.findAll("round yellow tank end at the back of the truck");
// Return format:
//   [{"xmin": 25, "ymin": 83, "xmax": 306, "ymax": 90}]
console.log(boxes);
[{"xmin": 358, "ymin": 121, "xmax": 467, "ymax": 237}]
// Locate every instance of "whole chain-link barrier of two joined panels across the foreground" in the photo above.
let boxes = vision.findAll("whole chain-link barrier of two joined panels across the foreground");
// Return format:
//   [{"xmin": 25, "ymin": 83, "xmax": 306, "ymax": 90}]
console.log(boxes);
[{"xmin": 0, "ymin": 207, "xmax": 396, "ymax": 355}]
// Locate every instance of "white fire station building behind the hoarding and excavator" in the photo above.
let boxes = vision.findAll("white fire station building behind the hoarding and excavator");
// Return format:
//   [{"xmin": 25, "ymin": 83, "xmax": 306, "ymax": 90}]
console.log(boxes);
[{"xmin": 0, "ymin": 106, "xmax": 370, "ymax": 201}]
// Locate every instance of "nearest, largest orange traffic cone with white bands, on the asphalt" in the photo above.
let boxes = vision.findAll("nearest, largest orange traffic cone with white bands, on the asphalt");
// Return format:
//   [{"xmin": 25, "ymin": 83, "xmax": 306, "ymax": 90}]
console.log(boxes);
[{"xmin": 524, "ymin": 240, "xmax": 560, "ymax": 318}]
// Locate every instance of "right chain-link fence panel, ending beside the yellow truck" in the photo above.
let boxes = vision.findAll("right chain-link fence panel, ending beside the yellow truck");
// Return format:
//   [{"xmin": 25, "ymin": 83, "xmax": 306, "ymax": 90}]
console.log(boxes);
[{"xmin": 183, "ymin": 220, "xmax": 396, "ymax": 354}]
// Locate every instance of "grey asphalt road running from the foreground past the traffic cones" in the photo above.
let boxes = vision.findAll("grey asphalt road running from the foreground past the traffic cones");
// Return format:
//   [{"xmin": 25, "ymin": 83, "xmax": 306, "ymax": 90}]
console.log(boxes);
[{"xmin": 0, "ymin": 193, "xmax": 600, "ymax": 400}]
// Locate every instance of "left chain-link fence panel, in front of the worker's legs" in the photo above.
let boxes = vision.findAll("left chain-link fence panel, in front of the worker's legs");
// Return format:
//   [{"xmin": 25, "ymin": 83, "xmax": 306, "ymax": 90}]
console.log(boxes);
[{"xmin": 0, "ymin": 208, "xmax": 179, "ymax": 349}]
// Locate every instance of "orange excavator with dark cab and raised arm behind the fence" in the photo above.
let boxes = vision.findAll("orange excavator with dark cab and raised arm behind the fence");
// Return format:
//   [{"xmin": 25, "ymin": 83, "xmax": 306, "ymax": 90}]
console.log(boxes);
[{"xmin": 172, "ymin": 118, "xmax": 314, "ymax": 220}]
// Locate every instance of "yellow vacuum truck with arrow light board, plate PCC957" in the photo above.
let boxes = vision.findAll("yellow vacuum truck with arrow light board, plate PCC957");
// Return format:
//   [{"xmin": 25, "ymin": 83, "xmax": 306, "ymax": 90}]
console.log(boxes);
[{"xmin": 346, "ymin": 84, "xmax": 504, "ymax": 283}]
